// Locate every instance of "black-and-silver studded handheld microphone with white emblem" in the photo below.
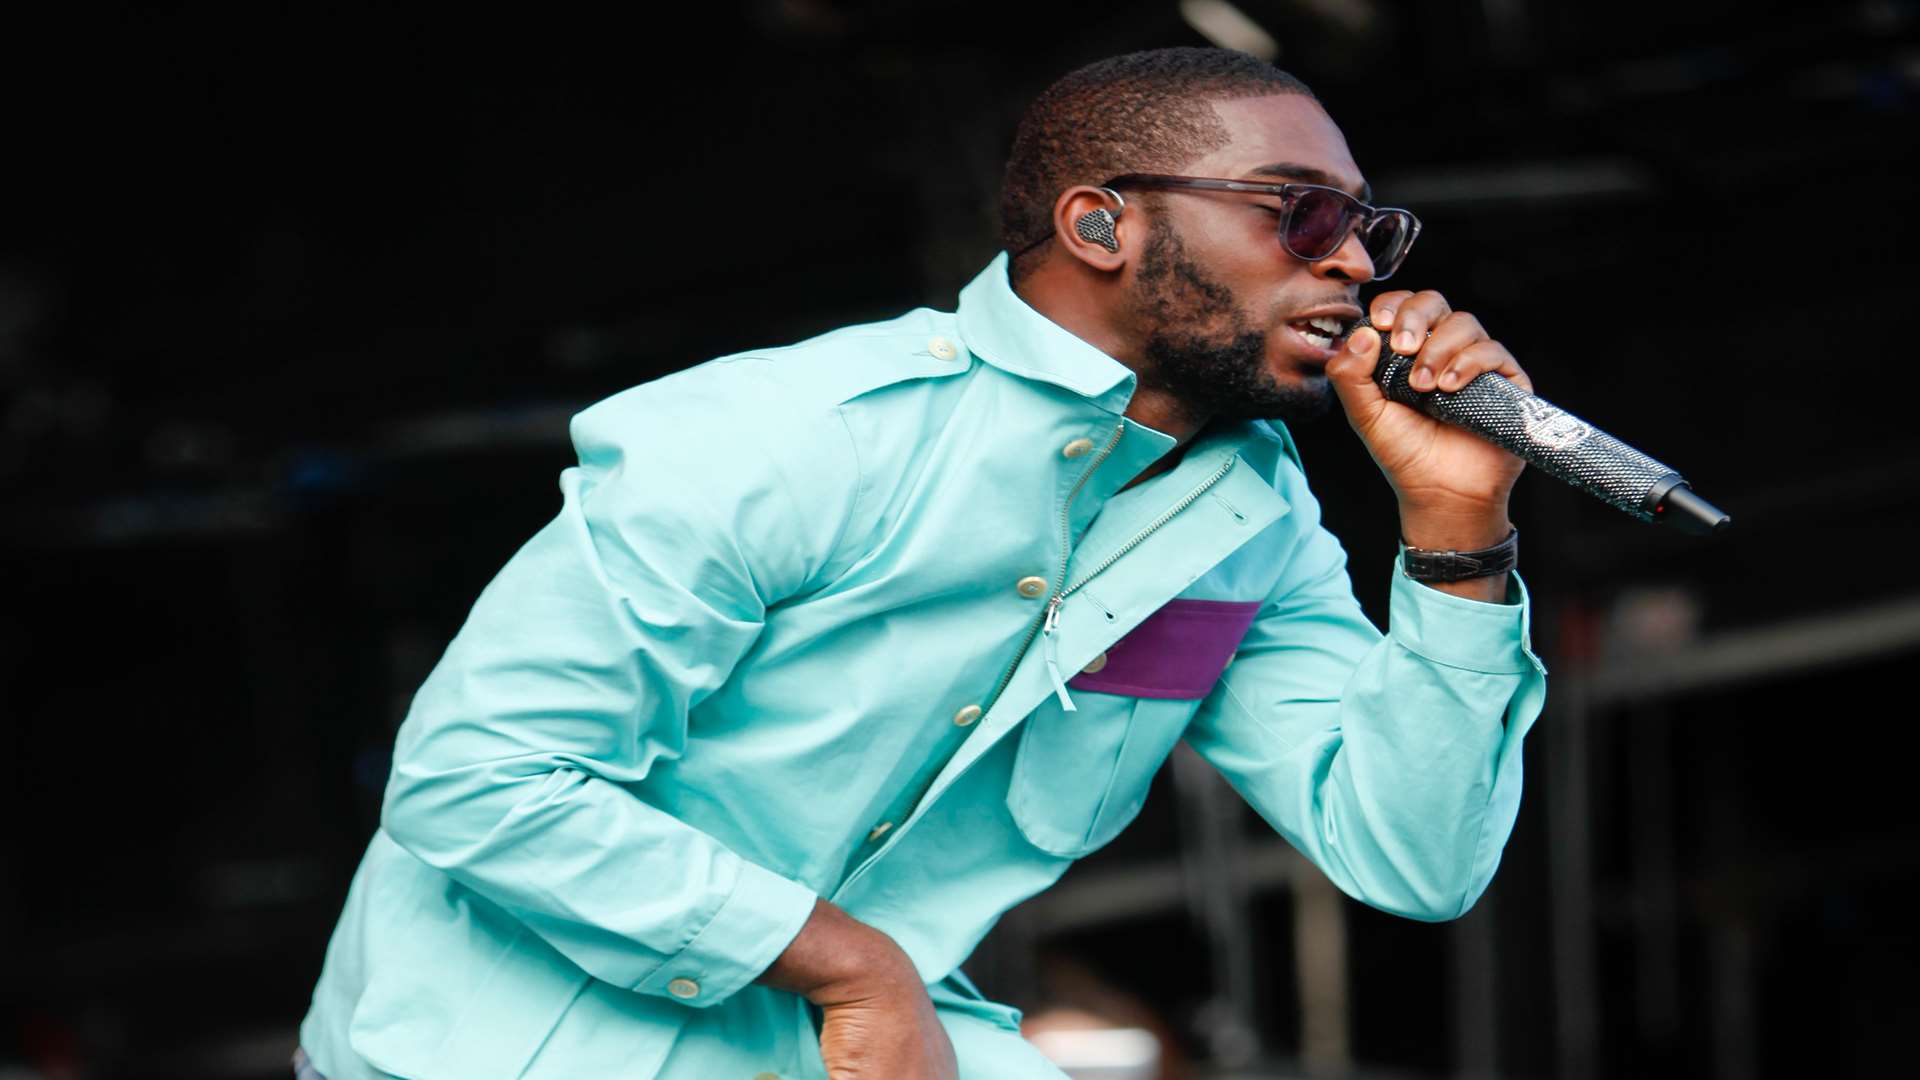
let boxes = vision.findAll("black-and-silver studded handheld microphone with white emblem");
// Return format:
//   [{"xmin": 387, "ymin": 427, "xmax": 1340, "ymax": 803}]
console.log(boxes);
[{"xmin": 1359, "ymin": 317, "xmax": 1734, "ymax": 536}]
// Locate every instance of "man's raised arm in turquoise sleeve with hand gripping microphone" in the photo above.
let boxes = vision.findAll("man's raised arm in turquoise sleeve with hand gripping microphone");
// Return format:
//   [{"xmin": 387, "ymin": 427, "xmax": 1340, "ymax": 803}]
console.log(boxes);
[{"xmin": 1187, "ymin": 290, "xmax": 1546, "ymax": 919}]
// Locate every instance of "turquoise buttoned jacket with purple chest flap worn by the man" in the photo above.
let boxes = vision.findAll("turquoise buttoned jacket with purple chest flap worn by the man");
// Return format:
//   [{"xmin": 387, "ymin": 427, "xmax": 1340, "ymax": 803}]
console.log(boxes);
[{"xmin": 301, "ymin": 254, "xmax": 1546, "ymax": 1080}]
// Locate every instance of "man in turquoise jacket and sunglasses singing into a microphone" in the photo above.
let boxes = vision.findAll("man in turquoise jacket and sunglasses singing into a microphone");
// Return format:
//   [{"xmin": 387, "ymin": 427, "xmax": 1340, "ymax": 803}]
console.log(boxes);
[{"xmin": 296, "ymin": 48, "xmax": 1546, "ymax": 1080}]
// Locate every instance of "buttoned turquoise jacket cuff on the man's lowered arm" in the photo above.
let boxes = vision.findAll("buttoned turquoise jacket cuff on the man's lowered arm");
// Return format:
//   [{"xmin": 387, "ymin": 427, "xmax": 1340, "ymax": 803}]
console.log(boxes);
[{"xmin": 634, "ymin": 859, "xmax": 818, "ymax": 1009}]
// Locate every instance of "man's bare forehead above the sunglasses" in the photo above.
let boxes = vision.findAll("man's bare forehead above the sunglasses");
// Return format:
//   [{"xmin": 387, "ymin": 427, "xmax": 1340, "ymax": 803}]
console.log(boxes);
[{"xmin": 1188, "ymin": 94, "xmax": 1369, "ymax": 198}]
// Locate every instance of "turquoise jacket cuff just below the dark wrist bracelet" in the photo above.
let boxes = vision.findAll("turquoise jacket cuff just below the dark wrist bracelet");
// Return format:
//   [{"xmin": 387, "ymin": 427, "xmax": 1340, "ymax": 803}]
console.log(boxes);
[{"xmin": 1386, "ymin": 546, "xmax": 1546, "ymax": 675}]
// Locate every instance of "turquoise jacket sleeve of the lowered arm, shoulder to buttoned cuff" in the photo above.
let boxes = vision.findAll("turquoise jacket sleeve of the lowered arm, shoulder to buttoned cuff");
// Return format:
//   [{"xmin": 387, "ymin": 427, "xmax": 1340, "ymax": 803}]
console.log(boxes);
[{"xmin": 380, "ymin": 359, "xmax": 858, "ymax": 1007}]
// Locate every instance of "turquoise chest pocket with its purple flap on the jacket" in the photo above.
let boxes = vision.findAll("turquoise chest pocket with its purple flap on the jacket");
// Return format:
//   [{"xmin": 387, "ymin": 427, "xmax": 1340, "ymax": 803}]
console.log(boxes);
[{"xmin": 1006, "ymin": 600, "xmax": 1260, "ymax": 859}]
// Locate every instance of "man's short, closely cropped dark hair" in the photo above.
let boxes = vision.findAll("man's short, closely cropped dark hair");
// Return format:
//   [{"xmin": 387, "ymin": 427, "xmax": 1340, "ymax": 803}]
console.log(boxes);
[{"xmin": 1000, "ymin": 48, "xmax": 1317, "ymax": 282}]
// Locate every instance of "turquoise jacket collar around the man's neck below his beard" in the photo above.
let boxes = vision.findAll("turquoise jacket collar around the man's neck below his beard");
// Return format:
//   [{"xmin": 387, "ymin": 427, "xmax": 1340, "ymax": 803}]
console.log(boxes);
[{"xmin": 958, "ymin": 252, "xmax": 1290, "ymax": 452}]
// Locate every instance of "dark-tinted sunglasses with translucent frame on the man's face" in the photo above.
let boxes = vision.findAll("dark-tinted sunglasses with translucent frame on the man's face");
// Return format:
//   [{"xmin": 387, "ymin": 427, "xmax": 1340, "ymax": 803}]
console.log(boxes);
[{"xmin": 1100, "ymin": 173, "xmax": 1421, "ymax": 281}]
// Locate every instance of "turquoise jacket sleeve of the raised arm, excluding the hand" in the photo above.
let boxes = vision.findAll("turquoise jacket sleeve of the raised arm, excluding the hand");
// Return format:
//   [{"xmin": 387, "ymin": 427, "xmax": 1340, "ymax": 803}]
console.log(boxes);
[{"xmin": 1187, "ymin": 468, "xmax": 1546, "ymax": 920}]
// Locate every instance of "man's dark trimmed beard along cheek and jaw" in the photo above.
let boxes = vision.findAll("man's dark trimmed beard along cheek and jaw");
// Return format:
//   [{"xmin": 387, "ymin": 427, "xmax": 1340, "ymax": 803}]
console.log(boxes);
[{"xmin": 1133, "ymin": 213, "xmax": 1334, "ymax": 421}]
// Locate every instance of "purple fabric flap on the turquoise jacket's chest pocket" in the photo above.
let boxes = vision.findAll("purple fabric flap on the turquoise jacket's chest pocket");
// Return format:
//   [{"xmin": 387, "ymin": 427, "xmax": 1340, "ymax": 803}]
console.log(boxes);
[{"xmin": 1068, "ymin": 600, "xmax": 1260, "ymax": 698}]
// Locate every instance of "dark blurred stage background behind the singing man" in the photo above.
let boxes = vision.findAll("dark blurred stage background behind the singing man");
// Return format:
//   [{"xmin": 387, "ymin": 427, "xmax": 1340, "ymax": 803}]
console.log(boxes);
[{"xmin": 0, "ymin": 0, "xmax": 1920, "ymax": 1080}]
